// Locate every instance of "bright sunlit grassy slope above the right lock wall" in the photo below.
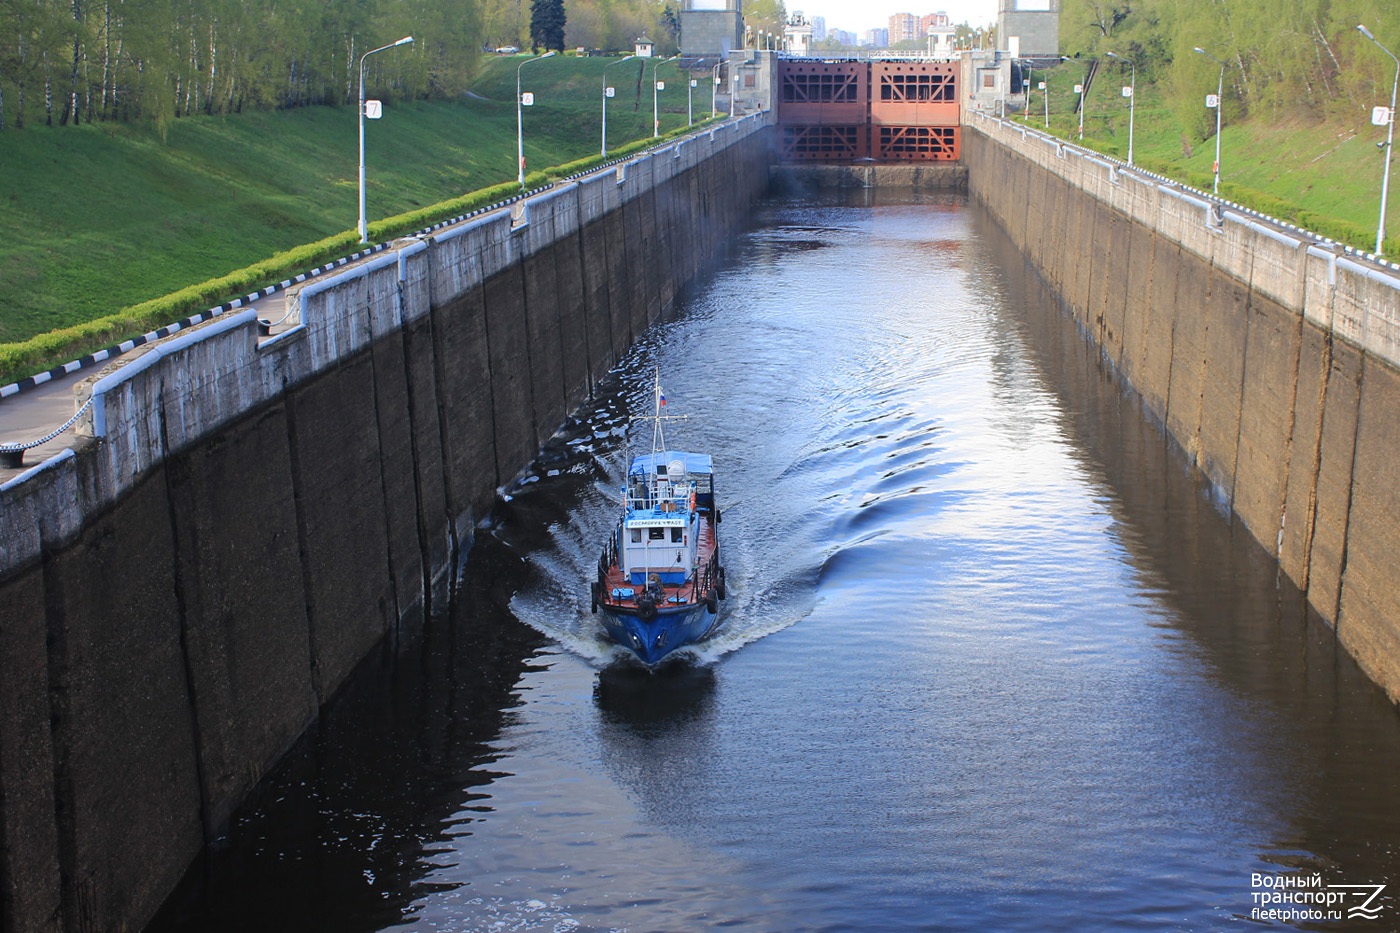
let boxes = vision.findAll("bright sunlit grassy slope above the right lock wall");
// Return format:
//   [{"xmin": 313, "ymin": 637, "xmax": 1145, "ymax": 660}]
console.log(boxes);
[{"xmin": 1016, "ymin": 62, "xmax": 1394, "ymax": 249}]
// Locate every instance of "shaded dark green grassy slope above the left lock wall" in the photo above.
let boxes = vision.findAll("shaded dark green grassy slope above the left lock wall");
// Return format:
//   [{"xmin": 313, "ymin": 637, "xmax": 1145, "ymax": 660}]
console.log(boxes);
[{"xmin": 0, "ymin": 57, "xmax": 708, "ymax": 343}]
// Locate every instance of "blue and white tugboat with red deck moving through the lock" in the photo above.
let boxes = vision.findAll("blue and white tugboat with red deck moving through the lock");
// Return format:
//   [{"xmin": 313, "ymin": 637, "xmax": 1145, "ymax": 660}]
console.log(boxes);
[{"xmin": 591, "ymin": 373, "xmax": 725, "ymax": 667}]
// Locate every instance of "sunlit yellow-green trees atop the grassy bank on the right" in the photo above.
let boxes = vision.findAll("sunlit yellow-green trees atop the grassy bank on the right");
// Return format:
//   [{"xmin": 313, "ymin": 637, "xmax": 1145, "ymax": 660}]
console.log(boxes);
[{"xmin": 1060, "ymin": 0, "xmax": 1400, "ymax": 139}]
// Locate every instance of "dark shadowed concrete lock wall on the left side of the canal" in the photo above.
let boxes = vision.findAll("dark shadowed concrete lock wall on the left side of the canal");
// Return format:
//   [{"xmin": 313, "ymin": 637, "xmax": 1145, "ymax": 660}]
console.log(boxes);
[{"xmin": 0, "ymin": 115, "xmax": 769, "ymax": 933}]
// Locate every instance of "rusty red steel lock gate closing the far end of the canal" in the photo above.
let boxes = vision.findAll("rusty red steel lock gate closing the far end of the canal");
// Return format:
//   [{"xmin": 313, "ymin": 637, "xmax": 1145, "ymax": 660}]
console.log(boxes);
[{"xmin": 777, "ymin": 59, "xmax": 962, "ymax": 163}]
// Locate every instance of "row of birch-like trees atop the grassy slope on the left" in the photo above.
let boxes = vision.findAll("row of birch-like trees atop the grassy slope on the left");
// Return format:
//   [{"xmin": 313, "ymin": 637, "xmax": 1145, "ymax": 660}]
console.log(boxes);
[{"xmin": 0, "ymin": 0, "xmax": 480, "ymax": 129}]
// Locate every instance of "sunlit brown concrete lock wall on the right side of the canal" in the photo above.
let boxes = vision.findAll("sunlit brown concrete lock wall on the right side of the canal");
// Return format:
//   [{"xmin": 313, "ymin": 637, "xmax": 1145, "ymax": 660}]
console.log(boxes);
[{"xmin": 963, "ymin": 115, "xmax": 1400, "ymax": 700}]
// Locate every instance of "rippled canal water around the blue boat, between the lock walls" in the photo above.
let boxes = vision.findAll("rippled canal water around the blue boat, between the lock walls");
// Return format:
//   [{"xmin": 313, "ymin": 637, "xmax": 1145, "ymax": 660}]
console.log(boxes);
[{"xmin": 157, "ymin": 192, "xmax": 1400, "ymax": 930}]
